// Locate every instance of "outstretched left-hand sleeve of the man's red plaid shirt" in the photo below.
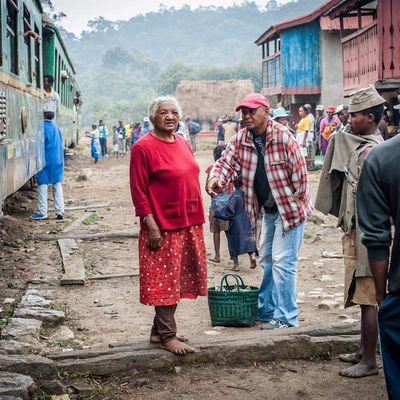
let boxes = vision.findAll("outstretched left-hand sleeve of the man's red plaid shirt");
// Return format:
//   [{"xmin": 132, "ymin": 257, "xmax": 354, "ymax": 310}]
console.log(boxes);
[{"xmin": 209, "ymin": 134, "xmax": 242, "ymax": 186}]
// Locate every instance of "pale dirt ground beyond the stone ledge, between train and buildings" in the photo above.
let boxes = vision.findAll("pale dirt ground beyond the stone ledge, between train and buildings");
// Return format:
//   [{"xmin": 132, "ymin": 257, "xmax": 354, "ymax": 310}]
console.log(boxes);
[{"xmin": 0, "ymin": 138, "xmax": 359, "ymax": 348}]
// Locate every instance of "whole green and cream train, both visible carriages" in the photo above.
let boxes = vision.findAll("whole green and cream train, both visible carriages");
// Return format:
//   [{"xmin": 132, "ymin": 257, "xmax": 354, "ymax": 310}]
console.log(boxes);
[{"xmin": 0, "ymin": 0, "xmax": 80, "ymax": 216}]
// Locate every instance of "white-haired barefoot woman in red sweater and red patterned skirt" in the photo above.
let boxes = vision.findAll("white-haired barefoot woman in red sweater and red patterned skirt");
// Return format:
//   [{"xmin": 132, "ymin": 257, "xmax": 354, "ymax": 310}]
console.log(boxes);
[{"xmin": 130, "ymin": 97, "xmax": 207, "ymax": 355}]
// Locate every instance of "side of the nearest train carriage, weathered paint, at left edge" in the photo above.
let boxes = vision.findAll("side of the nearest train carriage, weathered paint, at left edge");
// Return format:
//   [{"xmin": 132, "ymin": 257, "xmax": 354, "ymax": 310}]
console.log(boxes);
[{"xmin": 0, "ymin": 0, "xmax": 44, "ymax": 215}]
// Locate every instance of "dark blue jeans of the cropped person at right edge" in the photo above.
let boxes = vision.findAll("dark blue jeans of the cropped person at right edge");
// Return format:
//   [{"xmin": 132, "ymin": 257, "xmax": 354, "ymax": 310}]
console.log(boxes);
[{"xmin": 378, "ymin": 294, "xmax": 400, "ymax": 400}]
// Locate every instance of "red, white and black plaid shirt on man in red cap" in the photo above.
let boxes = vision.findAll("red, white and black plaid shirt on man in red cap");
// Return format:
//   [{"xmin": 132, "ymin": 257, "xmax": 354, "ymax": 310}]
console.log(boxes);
[{"xmin": 210, "ymin": 119, "xmax": 312, "ymax": 231}]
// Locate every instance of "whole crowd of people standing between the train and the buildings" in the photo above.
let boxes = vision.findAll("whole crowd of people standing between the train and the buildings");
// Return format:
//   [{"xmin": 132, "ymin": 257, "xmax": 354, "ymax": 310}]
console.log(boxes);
[{"xmin": 27, "ymin": 77, "xmax": 400, "ymax": 399}]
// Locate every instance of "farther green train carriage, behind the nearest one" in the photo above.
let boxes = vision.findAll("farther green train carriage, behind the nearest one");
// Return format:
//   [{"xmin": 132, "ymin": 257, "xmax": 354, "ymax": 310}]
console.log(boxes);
[{"xmin": 43, "ymin": 15, "xmax": 80, "ymax": 147}]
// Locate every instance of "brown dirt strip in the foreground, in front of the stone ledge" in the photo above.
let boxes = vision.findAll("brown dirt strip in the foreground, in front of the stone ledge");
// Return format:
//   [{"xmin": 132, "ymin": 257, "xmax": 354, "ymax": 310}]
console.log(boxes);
[{"xmin": 72, "ymin": 361, "xmax": 387, "ymax": 400}]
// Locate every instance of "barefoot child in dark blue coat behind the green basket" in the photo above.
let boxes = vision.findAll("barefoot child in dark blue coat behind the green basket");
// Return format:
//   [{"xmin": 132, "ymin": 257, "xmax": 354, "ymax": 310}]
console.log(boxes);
[{"xmin": 214, "ymin": 177, "xmax": 257, "ymax": 271}]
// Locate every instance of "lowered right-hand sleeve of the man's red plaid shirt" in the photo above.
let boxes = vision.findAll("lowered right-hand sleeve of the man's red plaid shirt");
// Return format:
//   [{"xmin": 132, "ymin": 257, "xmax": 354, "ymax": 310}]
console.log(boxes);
[{"xmin": 287, "ymin": 136, "xmax": 308, "ymax": 202}]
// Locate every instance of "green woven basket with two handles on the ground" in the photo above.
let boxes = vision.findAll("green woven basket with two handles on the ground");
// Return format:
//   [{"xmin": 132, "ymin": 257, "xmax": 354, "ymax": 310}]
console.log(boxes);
[{"xmin": 208, "ymin": 274, "xmax": 259, "ymax": 327}]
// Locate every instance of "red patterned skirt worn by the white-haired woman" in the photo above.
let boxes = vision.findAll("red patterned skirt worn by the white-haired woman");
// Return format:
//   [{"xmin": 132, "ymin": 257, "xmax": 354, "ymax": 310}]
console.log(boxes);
[{"xmin": 139, "ymin": 225, "xmax": 207, "ymax": 306}]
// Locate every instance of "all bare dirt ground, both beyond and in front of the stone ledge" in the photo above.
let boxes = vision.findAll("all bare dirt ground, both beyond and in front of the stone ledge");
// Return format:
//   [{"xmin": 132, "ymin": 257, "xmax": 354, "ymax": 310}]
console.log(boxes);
[{"xmin": 0, "ymin": 139, "xmax": 385, "ymax": 400}]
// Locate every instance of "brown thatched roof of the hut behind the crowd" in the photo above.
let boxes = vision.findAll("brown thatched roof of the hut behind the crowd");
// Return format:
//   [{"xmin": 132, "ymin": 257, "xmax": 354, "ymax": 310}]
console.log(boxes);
[{"xmin": 176, "ymin": 79, "xmax": 254, "ymax": 121}]
